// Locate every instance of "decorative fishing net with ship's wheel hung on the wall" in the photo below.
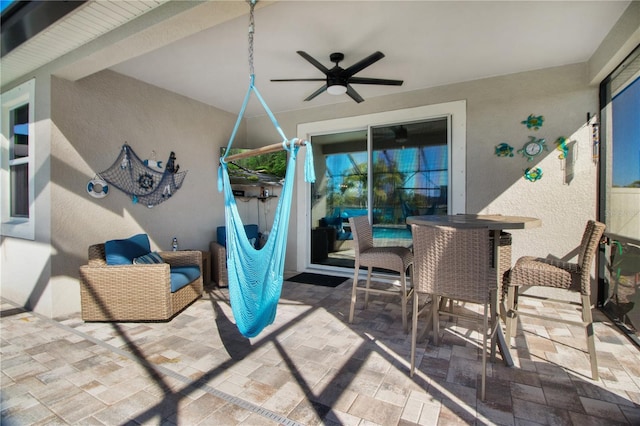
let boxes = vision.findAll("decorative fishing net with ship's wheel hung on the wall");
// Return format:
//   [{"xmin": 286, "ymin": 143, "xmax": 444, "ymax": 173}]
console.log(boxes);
[{"xmin": 98, "ymin": 144, "xmax": 187, "ymax": 207}]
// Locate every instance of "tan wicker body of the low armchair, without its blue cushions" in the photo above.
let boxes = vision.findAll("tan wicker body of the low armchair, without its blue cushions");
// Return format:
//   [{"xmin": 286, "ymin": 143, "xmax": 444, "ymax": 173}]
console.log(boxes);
[{"xmin": 80, "ymin": 244, "xmax": 203, "ymax": 321}]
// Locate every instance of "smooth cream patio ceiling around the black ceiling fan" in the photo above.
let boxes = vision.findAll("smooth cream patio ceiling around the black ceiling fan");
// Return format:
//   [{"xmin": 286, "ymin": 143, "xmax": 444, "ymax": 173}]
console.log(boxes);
[{"xmin": 2, "ymin": 0, "xmax": 630, "ymax": 116}]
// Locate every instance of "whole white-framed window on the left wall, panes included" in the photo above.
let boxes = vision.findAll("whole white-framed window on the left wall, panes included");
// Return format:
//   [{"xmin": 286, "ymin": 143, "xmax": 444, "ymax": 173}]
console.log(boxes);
[{"xmin": 0, "ymin": 80, "xmax": 35, "ymax": 239}]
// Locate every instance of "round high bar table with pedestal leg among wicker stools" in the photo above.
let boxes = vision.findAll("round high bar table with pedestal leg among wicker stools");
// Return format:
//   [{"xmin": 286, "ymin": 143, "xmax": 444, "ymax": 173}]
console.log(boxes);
[{"xmin": 407, "ymin": 214, "xmax": 542, "ymax": 367}]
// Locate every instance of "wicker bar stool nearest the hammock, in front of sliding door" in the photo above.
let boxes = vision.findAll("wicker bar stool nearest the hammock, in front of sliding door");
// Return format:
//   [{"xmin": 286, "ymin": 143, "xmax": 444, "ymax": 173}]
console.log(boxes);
[{"xmin": 349, "ymin": 216, "xmax": 413, "ymax": 333}]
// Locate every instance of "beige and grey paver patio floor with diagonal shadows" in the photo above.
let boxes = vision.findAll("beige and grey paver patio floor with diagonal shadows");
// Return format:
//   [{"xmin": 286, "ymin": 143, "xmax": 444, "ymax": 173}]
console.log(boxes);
[{"xmin": 0, "ymin": 280, "xmax": 640, "ymax": 425}]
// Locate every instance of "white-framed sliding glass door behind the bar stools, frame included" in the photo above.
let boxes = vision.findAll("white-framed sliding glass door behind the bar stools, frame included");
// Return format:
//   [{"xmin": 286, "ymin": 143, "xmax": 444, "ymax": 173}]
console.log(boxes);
[{"xmin": 292, "ymin": 100, "xmax": 467, "ymax": 273}]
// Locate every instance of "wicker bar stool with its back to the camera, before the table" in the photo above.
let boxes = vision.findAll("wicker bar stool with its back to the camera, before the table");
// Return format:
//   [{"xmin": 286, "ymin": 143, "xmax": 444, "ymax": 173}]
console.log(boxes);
[{"xmin": 411, "ymin": 225, "xmax": 497, "ymax": 400}]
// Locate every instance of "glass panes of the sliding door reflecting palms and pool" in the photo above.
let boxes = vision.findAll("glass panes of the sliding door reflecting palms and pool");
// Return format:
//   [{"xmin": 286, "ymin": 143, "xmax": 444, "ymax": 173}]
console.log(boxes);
[{"xmin": 311, "ymin": 118, "xmax": 450, "ymax": 268}]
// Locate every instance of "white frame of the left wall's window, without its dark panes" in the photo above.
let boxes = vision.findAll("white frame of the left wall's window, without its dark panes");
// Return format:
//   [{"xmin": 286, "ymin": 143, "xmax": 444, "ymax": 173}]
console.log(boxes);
[{"xmin": 0, "ymin": 79, "xmax": 36, "ymax": 240}]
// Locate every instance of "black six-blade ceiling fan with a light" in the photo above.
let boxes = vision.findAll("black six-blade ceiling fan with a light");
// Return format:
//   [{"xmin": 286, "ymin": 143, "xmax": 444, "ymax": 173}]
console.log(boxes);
[{"xmin": 271, "ymin": 50, "xmax": 403, "ymax": 103}]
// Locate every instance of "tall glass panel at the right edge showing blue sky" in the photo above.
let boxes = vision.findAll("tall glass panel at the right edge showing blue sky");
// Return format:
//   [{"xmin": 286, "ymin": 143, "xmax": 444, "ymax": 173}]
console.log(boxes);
[{"xmin": 599, "ymin": 43, "xmax": 640, "ymax": 342}]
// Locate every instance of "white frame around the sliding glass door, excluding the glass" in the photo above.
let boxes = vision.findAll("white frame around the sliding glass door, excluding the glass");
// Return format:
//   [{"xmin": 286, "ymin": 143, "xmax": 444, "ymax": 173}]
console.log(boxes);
[{"xmin": 295, "ymin": 100, "xmax": 467, "ymax": 272}]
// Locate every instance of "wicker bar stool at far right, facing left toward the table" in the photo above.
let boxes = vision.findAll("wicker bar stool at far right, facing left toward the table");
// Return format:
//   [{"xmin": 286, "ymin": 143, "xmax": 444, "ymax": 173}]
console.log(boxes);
[{"xmin": 506, "ymin": 220, "xmax": 605, "ymax": 380}]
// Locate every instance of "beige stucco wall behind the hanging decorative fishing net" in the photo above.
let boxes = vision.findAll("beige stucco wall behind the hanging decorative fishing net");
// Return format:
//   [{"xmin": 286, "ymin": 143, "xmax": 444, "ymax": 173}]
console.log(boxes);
[{"xmin": 44, "ymin": 71, "xmax": 244, "ymax": 315}]
